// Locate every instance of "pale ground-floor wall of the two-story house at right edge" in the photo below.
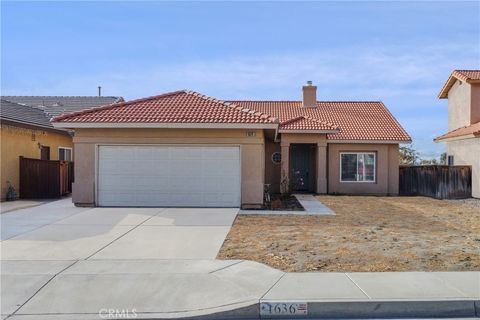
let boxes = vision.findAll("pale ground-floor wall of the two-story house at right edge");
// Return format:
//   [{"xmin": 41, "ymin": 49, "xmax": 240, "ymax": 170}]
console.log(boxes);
[{"xmin": 447, "ymin": 138, "xmax": 480, "ymax": 198}]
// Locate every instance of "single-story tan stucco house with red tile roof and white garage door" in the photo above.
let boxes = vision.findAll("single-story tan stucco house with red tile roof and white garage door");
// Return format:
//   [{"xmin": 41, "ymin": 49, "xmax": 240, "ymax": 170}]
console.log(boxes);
[{"xmin": 54, "ymin": 83, "xmax": 410, "ymax": 207}]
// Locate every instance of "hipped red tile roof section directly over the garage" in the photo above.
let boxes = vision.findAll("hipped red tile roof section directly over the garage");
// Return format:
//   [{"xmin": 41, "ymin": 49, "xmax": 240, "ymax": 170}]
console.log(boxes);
[{"xmin": 53, "ymin": 90, "xmax": 277, "ymax": 124}]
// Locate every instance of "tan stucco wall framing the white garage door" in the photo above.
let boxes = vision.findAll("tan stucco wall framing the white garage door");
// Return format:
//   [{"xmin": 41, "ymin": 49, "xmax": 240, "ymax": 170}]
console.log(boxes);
[{"xmin": 73, "ymin": 129, "xmax": 265, "ymax": 207}]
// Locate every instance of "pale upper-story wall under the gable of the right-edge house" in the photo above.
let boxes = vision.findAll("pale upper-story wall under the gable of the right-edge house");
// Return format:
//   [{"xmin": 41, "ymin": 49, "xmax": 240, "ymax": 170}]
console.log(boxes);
[{"xmin": 448, "ymin": 80, "xmax": 471, "ymax": 131}]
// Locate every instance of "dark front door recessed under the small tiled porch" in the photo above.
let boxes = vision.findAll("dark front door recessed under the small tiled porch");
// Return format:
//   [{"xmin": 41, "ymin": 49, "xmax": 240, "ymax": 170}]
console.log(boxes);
[{"xmin": 290, "ymin": 144, "xmax": 315, "ymax": 192}]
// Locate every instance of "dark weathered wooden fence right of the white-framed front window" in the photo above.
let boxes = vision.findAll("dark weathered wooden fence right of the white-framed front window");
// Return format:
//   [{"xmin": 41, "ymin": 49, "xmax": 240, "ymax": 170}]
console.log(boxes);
[{"xmin": 399, "ymin": 166, "xmax": 472, "ymax": 199}]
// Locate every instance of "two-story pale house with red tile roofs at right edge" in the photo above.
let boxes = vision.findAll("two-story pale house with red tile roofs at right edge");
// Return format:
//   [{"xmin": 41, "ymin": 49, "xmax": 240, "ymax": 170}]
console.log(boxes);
[{"xmin": 435, "ymin": 70, "xmax": 480, "ymax": 198}]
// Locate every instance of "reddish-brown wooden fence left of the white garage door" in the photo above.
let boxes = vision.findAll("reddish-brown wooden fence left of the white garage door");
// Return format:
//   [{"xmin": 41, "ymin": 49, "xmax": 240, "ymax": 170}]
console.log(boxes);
[{"xmin": 20, "ymin": 157, "xmax": 73, "ymax": 199}]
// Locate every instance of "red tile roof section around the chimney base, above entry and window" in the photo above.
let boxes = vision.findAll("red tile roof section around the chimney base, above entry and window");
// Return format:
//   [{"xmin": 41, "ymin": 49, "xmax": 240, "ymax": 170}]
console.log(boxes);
[{"xmin": 230, "ymin": 101, "xmax": 411, "ymax": 141}]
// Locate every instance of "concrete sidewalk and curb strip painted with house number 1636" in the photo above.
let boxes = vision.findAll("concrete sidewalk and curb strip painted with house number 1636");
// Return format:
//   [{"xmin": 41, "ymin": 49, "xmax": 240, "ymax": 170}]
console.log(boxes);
[{"xmin": 2, "ymin": 260, "xmax": 480, "ymax": 319}]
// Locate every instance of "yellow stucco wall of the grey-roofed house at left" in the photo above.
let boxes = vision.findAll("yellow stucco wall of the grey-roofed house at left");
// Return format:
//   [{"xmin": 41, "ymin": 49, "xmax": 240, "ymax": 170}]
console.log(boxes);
[{"xmin": 0, "ymin": 123, "xmax": 73, "ymax": 200}]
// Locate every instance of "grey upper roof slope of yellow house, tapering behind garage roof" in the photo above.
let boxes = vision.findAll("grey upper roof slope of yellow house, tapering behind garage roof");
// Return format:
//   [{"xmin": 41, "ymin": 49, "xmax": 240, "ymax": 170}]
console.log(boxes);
[{"xmin": 2, "ymin": 96, "xmax": 123, "ymax": 118}]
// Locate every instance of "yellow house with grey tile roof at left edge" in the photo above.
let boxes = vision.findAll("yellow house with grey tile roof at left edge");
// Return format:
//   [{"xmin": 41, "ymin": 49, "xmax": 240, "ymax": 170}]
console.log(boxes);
[{"xmin": 0, "ymin": 96, "xmax": 123, "ymax": 200}]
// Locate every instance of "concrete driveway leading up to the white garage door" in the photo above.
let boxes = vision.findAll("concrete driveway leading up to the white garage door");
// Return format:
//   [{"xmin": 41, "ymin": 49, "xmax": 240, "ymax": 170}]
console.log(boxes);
[{"xmin": 1, "ymin": 199, "xmax": 238, "ymax": 260}]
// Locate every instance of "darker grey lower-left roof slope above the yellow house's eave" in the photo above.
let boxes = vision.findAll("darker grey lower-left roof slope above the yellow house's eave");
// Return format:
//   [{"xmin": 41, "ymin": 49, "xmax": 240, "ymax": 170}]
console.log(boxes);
[{"xmin": 0, "ymin": 99, "xmax": 53, "ymax": 128}]
